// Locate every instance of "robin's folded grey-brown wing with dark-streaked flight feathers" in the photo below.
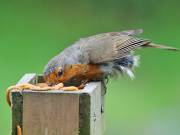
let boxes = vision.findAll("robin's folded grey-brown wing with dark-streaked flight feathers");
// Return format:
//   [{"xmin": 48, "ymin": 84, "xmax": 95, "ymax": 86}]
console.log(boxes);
[{"xmin": 77, "ymin": 30, "xmax": 150, "ymax": 63}]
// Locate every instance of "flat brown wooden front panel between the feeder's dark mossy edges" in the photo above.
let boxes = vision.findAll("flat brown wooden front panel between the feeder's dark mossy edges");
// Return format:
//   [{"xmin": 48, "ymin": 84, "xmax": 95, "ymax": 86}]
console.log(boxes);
[{"xmin": 23, "ymin": 92, "xmax": 79, "ymax": 135}]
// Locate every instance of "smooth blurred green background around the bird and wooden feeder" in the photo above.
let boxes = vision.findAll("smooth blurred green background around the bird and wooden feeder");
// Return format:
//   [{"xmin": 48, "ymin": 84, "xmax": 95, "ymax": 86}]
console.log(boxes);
[{"xmin": 0, "ymin": 0, "xmax": 180, "ymax": 135}]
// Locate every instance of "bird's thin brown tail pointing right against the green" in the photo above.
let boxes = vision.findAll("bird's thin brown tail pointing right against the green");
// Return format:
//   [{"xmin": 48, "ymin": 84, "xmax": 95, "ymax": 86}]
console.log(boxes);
[{"xmin": 145, "ymin": 43, "xmax": 180, "ymax": 51}]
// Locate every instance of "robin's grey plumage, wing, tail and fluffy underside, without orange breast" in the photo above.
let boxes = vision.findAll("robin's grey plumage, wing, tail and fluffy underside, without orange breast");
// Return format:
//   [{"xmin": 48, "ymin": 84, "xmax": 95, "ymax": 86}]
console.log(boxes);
[{"xmin": 44, "ymin": 29, "xmax": 177, "ymax": 82}]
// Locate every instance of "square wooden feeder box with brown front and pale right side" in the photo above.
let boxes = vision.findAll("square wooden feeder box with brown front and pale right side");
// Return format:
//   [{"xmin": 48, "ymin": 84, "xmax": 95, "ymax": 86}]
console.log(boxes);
[{"xmin": 12, "ymin": 74, "xmax": 104, "ymax": 135}]
